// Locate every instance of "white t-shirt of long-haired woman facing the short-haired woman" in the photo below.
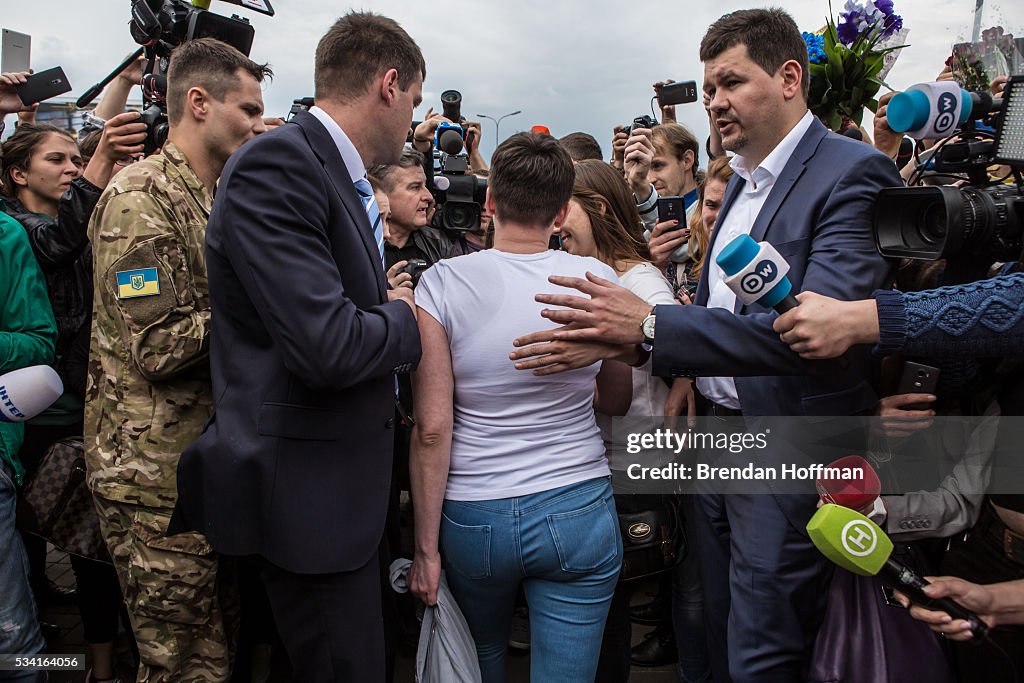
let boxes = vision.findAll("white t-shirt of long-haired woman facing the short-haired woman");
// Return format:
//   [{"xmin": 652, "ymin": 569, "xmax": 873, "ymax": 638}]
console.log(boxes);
[{"xmin": 597, "ymin": 262, "xmax": 679, "ymax": 470}]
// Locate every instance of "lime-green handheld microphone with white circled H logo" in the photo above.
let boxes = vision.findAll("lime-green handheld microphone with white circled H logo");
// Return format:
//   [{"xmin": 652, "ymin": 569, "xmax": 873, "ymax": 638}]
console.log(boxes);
[{"xmin": 807, "ymin": 504, "xmax": 988, "ymax": 639}]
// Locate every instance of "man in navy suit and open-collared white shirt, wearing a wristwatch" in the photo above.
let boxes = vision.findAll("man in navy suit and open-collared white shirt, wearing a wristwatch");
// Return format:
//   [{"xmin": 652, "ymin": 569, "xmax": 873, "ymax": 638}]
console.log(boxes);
[{"xmin": 514, "ymin": 9, "xmax": 901, "ymax": 683}]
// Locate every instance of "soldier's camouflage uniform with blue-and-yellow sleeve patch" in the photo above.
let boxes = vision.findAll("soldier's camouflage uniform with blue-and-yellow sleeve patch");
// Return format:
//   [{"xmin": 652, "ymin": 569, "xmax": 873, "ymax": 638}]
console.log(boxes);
[{"xmin": 85, "ymin": 143, "xmax": 236, "ymax": 683}]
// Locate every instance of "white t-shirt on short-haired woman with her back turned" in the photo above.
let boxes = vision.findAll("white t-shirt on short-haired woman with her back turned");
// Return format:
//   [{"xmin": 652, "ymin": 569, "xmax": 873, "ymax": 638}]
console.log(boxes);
[{"xmin": 416, "ymin": 249, "xmax": 617, "ymax": 501}]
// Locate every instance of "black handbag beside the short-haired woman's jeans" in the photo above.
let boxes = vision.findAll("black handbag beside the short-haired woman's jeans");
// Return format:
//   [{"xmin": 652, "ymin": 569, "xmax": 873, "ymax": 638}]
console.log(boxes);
[{"xmin": 615, "ymin": 496, "xmax": 686, "ymax": 581}]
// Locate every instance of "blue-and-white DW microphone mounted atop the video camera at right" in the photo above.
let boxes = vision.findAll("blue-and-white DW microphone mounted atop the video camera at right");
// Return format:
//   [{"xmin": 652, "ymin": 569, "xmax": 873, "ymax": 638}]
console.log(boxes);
[{"xmin": 886, "ymin": 81, "xmax": 1002, "ymax": 140}]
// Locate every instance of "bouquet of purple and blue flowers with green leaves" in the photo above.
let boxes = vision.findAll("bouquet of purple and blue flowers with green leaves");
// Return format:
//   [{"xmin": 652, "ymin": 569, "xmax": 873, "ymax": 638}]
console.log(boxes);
[{"xmin": 803, "ymin": 0, "xmax": 908, "ymax": 130}]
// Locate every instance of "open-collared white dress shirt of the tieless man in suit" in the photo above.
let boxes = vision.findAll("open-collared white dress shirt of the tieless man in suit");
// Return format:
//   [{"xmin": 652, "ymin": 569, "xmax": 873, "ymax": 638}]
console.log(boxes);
[{"xmin": 697, "ymin": 112, "xmax": 814, "ymax": 411}]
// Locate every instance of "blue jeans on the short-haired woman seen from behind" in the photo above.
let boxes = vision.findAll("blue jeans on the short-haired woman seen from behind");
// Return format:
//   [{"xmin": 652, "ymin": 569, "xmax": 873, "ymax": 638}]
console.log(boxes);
[{"xmin": 440, "ymin": 477, "xmax": 623, "ymax": 683}]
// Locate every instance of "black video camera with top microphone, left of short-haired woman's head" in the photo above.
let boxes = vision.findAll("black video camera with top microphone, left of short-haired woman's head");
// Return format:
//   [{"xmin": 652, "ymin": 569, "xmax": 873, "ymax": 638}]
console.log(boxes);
[{"xmin": 427, "ymin": 90, "xmax": 487, "ymax": 232}]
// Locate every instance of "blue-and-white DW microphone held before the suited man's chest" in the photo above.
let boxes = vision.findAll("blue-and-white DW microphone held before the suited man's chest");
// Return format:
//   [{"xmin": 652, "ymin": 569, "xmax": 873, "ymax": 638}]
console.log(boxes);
[{"xmin": 715, "ymin": 234, "xmax": 800, "ymax": 313}]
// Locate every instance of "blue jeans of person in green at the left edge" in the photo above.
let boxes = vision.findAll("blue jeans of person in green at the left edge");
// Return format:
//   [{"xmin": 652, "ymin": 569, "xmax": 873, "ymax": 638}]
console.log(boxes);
[{"xmin": 0, "ymin": 462, "xmax": 46, "ymax": 681}]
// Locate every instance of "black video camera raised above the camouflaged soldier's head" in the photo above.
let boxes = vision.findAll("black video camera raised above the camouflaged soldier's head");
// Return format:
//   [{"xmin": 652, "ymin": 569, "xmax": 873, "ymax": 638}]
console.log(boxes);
[{"xmin": 129, "ymin": 0, "xmax": 273, "ymax": 155}]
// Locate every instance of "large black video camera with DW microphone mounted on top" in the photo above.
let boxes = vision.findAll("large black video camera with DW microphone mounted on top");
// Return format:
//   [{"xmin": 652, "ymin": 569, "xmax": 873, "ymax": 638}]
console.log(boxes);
[{"xmin": 874, "ymin": 76, "xmax": 1024, "ymax": 285}]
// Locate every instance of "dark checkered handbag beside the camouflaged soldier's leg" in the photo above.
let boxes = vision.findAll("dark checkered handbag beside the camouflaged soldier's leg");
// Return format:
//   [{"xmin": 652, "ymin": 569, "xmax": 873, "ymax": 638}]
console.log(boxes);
[{"xmin": 17, "ymin": 436, "xmax": 111, "ymax": 562}]
